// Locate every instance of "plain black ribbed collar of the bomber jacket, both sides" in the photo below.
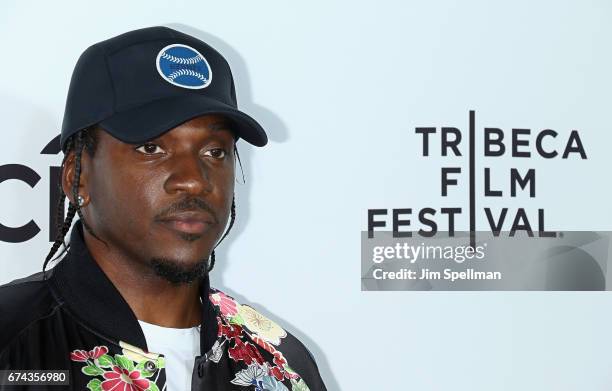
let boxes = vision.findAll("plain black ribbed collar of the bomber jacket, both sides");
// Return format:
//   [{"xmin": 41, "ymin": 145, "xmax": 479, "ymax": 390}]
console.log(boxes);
[{"xmin": 49, "ymin": 220, "xmax": 218, "ymax": 355}]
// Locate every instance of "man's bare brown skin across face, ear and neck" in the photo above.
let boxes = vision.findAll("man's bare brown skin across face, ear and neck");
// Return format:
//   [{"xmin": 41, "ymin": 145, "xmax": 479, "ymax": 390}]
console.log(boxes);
[{"xmin": 62, "ymin": 115, "xmax": 235, "ymax": 328}]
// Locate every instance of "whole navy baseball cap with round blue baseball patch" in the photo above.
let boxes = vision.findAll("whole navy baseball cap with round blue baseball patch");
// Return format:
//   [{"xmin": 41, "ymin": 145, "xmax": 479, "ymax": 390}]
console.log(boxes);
[{"xmin": 60, "ymin": 27, "xmax": 268, "ymax": 152}]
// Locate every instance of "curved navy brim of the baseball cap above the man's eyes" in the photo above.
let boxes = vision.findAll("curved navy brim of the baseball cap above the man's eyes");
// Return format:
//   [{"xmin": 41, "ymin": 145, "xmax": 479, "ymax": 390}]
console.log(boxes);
[{"xmin": 100, "ymin": 94, "xmax": 268, "ymax": 147}]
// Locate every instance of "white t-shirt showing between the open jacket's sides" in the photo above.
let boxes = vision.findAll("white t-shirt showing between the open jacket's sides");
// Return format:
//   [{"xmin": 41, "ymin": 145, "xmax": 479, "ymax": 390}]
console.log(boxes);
[{"xmin": 138, "ymin": 320, "xmax": 200, "ymax": 391}]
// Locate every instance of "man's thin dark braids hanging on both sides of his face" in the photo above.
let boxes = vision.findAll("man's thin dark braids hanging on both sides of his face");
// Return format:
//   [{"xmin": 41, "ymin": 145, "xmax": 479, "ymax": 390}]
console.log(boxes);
[{"xmin": 43, "ymin": 130, "xmax": 244, "ymax": 278}]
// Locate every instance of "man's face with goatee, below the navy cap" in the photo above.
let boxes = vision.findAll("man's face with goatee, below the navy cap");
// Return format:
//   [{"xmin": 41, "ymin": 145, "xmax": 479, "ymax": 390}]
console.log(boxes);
[{"xmin": 66, "ymin": 115, "xmax": 235, "ymax": 282}]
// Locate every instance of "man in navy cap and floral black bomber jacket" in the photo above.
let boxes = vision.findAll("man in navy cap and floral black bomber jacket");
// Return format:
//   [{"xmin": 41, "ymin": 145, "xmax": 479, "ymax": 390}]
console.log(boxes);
[{"xmin": 0, "ymin": 27, "xmax": 325, "ymax": 391}]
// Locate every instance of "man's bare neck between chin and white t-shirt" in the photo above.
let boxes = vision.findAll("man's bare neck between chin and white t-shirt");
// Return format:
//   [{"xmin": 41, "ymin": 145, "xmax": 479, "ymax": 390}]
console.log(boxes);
[{"xmin": 83, "ymin": 230, "xmax": 202, "ymax": 328}]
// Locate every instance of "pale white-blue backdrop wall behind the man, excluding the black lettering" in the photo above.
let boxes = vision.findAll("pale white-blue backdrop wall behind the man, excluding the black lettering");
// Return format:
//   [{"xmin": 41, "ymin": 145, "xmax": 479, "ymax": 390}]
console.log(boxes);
[{"xmin": 0, "ymin": 0, "xmax": 612, "ymax": 391}]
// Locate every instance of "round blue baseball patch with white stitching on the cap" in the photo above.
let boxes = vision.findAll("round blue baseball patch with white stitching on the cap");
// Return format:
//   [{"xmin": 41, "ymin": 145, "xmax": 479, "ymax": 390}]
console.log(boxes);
[{"xmin": 155, "ymin": 43, "xmax": 212, "ymax": 90}]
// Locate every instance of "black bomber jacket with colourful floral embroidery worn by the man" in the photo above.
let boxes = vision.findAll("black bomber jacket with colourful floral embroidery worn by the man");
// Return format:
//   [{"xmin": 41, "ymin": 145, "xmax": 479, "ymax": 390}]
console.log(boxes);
[{"xmin": 0, "ymin": 221, "xmax": 326, "ymax": 391}]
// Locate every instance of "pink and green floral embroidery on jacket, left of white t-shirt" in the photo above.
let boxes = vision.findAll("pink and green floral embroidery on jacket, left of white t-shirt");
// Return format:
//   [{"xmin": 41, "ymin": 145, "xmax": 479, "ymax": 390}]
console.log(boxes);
[{"xmin": 70, "ymin": 342, "xmax": 165, "ymax": 391}]
